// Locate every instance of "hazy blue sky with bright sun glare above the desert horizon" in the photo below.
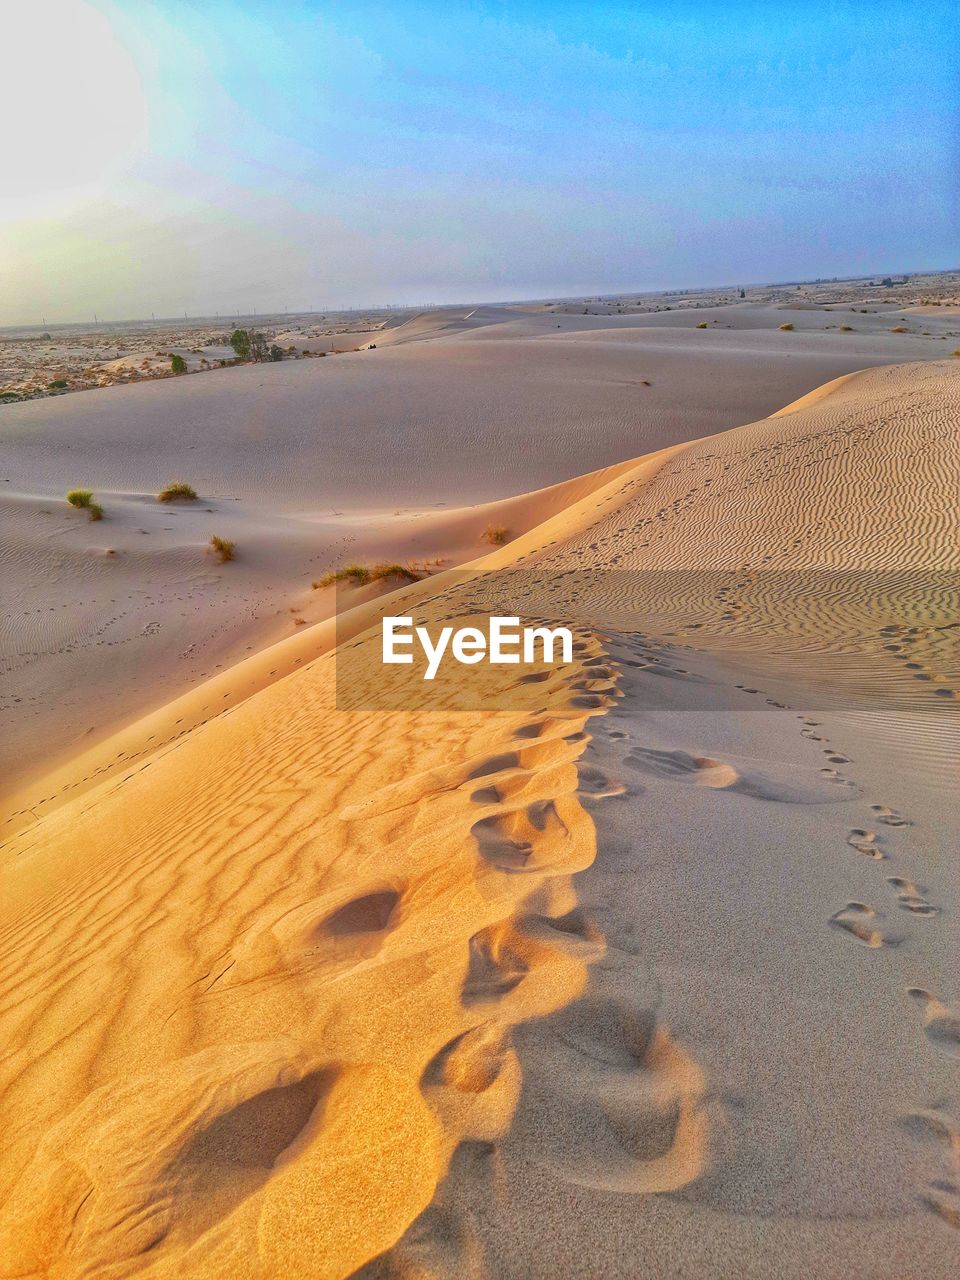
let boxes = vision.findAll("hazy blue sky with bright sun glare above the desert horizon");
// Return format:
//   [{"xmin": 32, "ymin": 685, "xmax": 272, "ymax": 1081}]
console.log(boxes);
[{"xmin": 0, "ymin": 0, "xmax": 960, "ymax": 325}]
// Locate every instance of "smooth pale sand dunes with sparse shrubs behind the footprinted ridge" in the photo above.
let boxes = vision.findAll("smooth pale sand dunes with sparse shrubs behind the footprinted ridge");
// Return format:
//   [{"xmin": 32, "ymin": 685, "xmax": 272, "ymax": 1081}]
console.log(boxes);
[{"xmin": 0, "ymin": 300, "xmax": 956, "ymax": 798}]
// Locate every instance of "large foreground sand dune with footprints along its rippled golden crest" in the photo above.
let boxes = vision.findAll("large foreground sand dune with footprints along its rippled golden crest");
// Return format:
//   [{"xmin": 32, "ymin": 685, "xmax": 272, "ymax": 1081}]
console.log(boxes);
[{"xmin": 0, "ymin": 355, "xmax": 960, "ymax": 1280}]
